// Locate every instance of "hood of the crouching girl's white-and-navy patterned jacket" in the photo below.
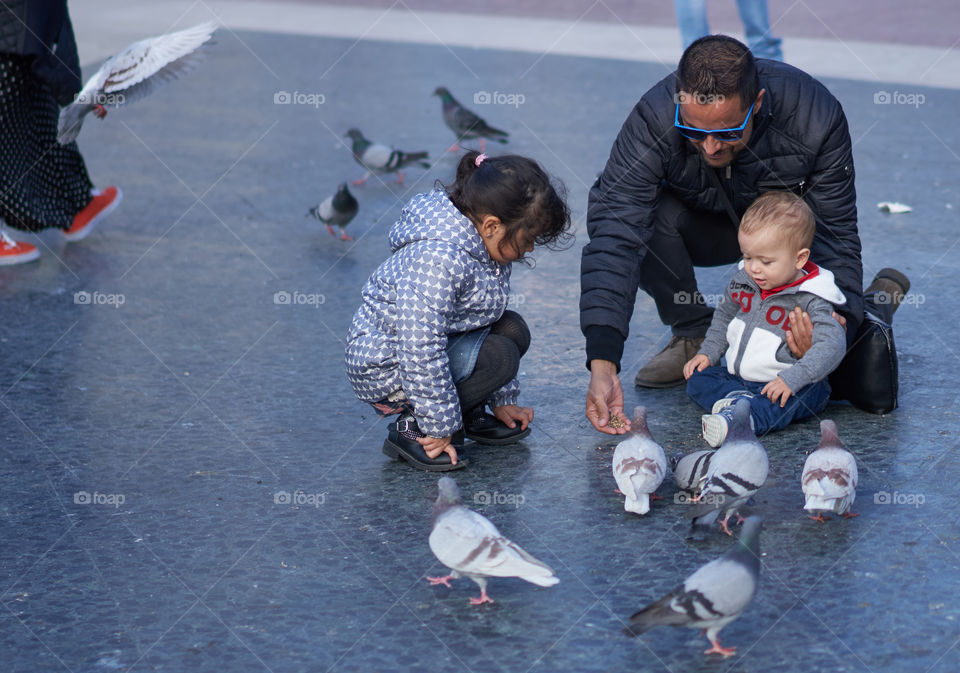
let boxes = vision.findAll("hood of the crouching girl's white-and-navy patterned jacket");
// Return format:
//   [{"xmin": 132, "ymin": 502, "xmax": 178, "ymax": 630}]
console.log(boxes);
[{"xmin": 390, "ymin": 189, "xmax": 493, "ymax": 264}]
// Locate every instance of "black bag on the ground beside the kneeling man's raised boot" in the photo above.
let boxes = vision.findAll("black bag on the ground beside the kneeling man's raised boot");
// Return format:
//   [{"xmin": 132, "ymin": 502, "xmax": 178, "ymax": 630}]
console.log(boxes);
[{"xmin": 830, "ymin": 313, "xmax": 899, "ymax": 414}]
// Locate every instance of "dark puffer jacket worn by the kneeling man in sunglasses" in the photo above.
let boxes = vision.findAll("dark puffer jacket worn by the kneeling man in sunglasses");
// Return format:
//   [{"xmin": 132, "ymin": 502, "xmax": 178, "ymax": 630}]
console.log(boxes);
[{"xmin": 580, "ymin": 59, "xmax": 863, "ymax": 364}]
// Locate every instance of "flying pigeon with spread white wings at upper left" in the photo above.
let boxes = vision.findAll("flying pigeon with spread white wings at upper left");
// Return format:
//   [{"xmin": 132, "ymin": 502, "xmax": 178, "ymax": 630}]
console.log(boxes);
[{"xmin": 57, "ymin": 22, "xmax": 217, "ymax": 145}]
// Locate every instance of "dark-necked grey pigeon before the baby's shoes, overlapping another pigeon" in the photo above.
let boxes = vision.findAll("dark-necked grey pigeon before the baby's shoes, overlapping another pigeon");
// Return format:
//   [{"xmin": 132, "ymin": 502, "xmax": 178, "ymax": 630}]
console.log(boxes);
[{"xmin": 687, "ymin": 398, "xmax": 770, "ymax": 535}]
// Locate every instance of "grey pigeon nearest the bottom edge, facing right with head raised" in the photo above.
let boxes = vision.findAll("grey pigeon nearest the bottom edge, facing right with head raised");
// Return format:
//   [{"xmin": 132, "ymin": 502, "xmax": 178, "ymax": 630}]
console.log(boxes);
[{"xmin": 624, "ymin": 516, "xmax": 763, "ymax": 657}]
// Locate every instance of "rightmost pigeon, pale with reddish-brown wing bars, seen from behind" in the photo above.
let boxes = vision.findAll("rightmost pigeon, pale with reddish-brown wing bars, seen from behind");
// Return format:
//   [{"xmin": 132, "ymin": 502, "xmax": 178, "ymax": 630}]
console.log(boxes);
[{"xmin": 800, "ymin": 421, "xmax": 857, "ymax": 522}]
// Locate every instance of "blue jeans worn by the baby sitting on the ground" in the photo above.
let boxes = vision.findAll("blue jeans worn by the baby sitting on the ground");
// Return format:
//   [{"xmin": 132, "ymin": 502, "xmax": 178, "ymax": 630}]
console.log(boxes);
[{"xmin": 687, "ymin": 367, "xmax": 830, "ymax": 437}]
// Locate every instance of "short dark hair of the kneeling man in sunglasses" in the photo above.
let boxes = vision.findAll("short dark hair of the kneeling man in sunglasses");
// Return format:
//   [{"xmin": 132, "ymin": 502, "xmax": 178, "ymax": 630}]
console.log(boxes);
[{"xmin": 677, "ymin": 35, "xmax": 760, "ymax": 110}]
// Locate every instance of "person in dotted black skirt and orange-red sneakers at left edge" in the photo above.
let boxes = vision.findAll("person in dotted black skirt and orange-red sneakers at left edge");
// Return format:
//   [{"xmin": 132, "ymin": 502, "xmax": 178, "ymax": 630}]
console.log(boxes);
[{"xmin": 0, "ymin": 0, "xmax": 122, "ymax": 265}]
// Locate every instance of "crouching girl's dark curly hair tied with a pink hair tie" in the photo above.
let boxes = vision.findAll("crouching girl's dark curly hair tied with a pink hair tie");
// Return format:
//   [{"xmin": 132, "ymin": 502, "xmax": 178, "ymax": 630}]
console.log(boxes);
[{"xmin": 443, "ymin": 151, "xmax": 573, "ymax": 260}]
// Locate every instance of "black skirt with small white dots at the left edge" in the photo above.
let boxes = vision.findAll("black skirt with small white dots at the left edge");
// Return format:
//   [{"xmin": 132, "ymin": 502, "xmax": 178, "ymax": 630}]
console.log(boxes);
[{"xmin": 0, "ymin": 54, "xmax": 93, "ymax": 231}]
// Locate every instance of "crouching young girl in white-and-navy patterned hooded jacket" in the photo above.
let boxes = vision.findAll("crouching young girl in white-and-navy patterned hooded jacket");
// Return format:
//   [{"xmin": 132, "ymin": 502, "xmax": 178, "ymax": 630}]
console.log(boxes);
[{"xmin": 346, "ymin": 152, "xmax": 571, "ymax": 471}]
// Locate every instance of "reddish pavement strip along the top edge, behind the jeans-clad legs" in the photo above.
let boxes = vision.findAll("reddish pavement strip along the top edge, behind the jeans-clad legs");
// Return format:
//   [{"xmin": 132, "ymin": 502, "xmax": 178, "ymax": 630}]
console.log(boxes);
[{"xmin": 262, "ymin": 0, "xmax": 960, "ymax": 47}]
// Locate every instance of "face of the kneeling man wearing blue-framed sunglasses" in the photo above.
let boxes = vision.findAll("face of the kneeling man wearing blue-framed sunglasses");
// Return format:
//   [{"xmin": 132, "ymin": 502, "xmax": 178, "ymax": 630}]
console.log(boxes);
[{"xmin": 680, "ymin": 90, "xmax": 764, "ymax": 168}]
